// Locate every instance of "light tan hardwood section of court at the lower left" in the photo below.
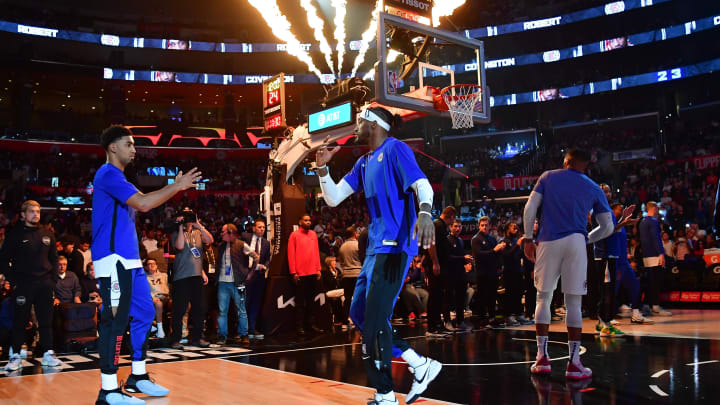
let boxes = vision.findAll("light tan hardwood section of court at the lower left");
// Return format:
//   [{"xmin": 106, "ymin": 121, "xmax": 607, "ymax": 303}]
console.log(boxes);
[{"xmin": 0, "ymin": 358, "xmax": 456, "ymax": 405}]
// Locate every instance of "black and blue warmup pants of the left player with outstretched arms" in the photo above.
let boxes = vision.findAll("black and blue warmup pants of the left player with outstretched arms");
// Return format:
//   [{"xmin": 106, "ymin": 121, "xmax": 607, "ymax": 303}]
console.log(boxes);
[{"xmin": 98, "ymin": 262, "xmax": 155, "ymax": 374}]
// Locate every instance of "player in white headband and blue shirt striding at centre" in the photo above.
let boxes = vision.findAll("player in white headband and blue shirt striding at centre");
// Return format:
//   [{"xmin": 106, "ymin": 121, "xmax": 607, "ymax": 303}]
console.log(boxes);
[{"xmin": 316, "ymin": 107, "xmax": 442, "ymax": 405}]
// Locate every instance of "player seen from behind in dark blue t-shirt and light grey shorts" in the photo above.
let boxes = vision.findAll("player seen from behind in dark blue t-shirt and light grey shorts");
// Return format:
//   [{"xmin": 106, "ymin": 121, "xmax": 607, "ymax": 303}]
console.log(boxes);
[{"xmin": 523, "ymin": 149, "xmax": 614, "ymax": 379}]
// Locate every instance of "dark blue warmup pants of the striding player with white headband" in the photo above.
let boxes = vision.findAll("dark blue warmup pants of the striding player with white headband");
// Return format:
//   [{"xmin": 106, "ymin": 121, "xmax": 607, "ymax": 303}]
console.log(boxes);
[{"xmin": 350, "ymin": 253, "xmax": 410, "ymax": 394}]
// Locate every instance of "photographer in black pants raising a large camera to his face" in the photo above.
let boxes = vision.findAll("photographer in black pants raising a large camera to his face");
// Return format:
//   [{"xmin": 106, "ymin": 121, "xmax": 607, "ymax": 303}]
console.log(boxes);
[{"xmin": 170, "ymin": 208, "xmax": 213, "ymax": 349}]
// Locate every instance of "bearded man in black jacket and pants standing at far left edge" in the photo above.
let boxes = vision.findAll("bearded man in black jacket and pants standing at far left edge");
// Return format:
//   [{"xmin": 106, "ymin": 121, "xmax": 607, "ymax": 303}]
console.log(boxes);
[{"xmin": 0, "ymin": 200, "xmax": 62, "ymax": 371}]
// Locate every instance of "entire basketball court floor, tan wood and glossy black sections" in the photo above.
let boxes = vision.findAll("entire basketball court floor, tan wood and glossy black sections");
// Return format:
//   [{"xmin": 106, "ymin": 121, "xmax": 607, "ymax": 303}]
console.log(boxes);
[{"xmin": 0, "ymin": 310, "xmax": 720, "ymax": 405}]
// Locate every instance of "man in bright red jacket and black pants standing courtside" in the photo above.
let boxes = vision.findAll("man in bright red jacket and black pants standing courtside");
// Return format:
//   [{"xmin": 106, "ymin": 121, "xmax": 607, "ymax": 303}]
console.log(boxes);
[{"xmin": 288, "ymin": 214, "xmax": 324, "ymax": 336}]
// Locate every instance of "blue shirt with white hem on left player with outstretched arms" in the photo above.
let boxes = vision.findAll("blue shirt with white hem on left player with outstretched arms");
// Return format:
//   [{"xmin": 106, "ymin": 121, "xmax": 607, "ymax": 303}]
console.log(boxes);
[{"xmin": 91, "ymin": 163, "xmax": 142, "ymax": 278}]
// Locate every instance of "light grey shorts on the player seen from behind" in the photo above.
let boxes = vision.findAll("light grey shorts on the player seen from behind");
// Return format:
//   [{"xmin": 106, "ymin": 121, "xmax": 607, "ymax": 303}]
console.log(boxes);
[{"xmin": 535, "ymin": 233, "xmax": 587, "ymax": 295}]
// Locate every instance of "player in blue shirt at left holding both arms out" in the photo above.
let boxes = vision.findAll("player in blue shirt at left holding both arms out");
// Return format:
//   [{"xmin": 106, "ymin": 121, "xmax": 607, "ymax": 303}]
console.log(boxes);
[{"xmin": 91, "ymin": 125, "xmax": 201, "ymax": 405}]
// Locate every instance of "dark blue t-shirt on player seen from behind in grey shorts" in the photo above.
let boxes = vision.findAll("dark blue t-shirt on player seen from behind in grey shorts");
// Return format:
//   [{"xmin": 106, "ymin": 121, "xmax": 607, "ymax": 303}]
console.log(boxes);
[{"xmin": 533, "ymin": 169, "xmax": 610, "ymax": 242}]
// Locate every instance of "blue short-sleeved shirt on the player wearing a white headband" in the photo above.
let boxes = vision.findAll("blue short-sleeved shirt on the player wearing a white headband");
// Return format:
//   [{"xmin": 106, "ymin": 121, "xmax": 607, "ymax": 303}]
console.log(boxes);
[{"xmin": 344, "ymin": 137, "xmax": 425, "ymax": 257}]
